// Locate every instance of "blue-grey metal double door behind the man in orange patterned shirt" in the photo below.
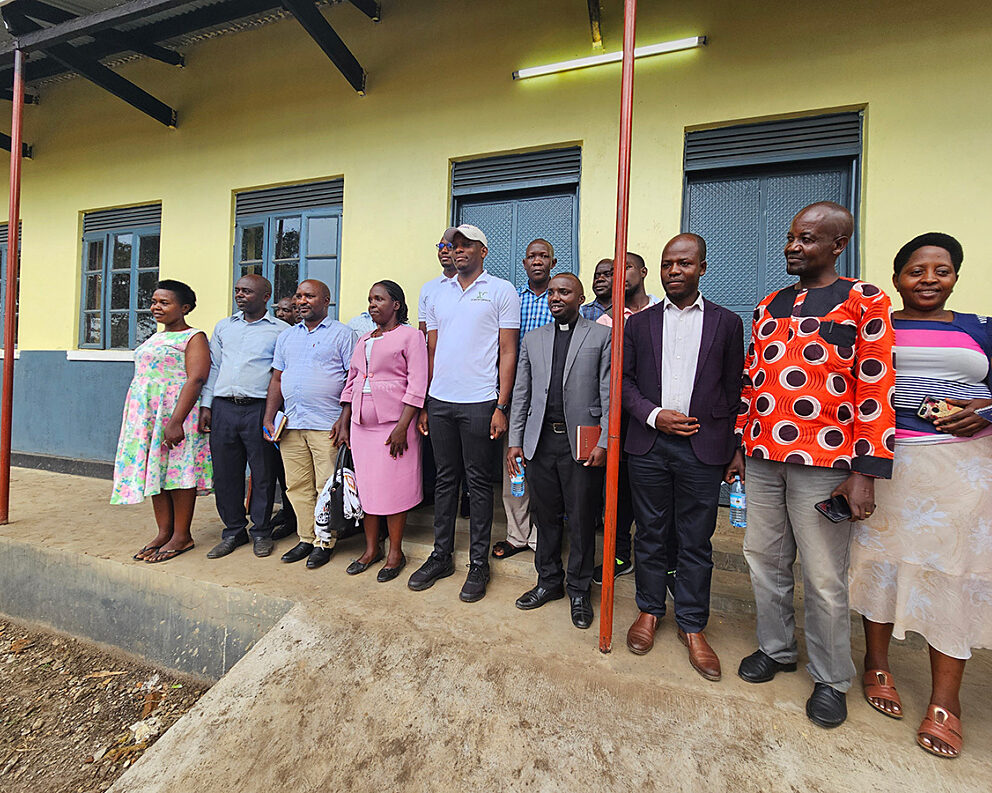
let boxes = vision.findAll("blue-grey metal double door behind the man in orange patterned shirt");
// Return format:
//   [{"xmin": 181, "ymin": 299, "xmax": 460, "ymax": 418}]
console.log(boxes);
[{"xmin": 682, "ymin": 113, "xmax": 861, "ymax": 333}]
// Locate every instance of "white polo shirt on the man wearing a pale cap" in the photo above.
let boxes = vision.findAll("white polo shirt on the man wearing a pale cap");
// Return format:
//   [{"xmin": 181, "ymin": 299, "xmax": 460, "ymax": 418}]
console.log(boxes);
[{"xmin": 427, "ymin": 270, "xmax": 520, "ymax": 404}]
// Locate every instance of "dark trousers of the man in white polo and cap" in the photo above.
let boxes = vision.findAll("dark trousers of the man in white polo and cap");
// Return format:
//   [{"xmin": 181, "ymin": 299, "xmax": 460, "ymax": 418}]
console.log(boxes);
[{"xmin": 427, "ymin": 398, "xmax": 499, "ymax": 568}]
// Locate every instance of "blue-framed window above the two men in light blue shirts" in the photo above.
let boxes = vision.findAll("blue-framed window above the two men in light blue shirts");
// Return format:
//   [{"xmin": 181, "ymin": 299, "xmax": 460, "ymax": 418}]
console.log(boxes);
[{"xmin": 234, "ymin": 179, "xmax": 344, "ymax": 319}]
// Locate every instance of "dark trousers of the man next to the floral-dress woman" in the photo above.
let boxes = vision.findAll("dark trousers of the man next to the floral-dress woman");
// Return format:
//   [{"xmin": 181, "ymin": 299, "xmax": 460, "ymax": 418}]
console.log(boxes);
[{"xmin": 210, "ymin": 397, "xmax": 276, "ymax": 539}]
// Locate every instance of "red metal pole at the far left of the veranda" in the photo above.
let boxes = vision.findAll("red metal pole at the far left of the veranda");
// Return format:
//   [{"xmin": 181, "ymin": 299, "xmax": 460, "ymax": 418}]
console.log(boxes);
[{"xmin": 0, "ymin": 50, "xmax": 24, "ymax": 524}]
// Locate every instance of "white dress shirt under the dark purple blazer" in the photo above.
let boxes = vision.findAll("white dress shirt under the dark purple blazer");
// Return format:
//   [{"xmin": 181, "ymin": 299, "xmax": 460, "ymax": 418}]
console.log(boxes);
[{"xmin": 647, "ymin": 294, "xmax": 703, "ymax": 429}]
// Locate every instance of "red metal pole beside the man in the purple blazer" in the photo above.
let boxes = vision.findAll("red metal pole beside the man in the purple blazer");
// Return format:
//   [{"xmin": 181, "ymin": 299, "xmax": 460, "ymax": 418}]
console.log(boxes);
[{"xmin": 599, "ymin": 0, "xmax": 637, "ymax": 653}]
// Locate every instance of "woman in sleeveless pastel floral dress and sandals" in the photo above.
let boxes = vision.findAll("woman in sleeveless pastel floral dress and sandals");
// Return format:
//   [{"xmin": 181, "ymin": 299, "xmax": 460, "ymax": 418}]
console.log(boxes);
[{"xmin": 110, "ymin": 280, "xmax": 213, "ymax": 562}]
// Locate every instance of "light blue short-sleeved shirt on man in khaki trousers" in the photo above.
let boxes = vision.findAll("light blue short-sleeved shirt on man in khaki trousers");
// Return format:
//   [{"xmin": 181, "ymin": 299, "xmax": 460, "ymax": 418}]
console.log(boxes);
[{"xmin": 272, "ymin": 317, "xmax": 355, "ymax": 430}]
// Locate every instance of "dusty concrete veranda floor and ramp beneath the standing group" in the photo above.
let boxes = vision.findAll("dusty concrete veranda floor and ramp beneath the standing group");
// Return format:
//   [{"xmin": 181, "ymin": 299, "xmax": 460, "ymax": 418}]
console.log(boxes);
[{"xmin": 0, "ymin": 469, "xmax": 992, "ymax": 793}]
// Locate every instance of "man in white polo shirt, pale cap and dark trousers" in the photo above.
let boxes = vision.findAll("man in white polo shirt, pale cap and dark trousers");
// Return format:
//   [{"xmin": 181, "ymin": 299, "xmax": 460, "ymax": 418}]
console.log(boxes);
[{"xmin": 408, "ymin": 224, "xmax": 520, "ymax": 603}]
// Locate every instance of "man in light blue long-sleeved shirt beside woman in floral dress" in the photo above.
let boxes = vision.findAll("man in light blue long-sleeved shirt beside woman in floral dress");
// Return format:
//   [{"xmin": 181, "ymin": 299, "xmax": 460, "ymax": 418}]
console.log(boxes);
[{"xmin": 200, "ymin": 275, "xmax": 289, "ymax": 559}]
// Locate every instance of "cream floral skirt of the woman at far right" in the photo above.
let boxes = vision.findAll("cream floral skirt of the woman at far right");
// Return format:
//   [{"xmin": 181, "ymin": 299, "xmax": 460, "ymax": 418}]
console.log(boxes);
[{"xmin": 850, "ymin": 436, "xmax": 992, "ymax": 658}]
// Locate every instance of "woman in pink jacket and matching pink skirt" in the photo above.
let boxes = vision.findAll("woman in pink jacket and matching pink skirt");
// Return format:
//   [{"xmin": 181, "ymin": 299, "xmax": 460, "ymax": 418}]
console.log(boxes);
[{"xmin": 332, "ymin": 281, "xmax": 427, "ymax": 582}]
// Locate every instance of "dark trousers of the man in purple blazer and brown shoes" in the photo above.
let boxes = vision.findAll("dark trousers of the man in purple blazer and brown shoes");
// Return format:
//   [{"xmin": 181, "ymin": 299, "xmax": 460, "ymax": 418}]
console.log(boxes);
[{"xmin": 627, "ymin": 433, "xmax": 724, "ymax": 633}]
